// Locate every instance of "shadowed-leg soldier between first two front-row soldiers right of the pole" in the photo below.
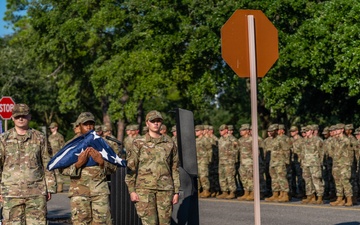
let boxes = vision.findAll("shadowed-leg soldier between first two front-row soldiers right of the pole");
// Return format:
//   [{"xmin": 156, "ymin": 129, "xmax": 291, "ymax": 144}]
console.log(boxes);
[{"xmin": 289, "ymin": 126, "xmax": 305, "ymax": 199}]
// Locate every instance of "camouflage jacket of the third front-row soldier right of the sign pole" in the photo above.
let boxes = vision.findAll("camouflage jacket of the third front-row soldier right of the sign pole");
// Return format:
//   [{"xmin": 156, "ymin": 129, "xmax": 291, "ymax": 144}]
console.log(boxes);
[{"xmin": 329, "ymin": 135, "xmax": 354, "ymax": 167}]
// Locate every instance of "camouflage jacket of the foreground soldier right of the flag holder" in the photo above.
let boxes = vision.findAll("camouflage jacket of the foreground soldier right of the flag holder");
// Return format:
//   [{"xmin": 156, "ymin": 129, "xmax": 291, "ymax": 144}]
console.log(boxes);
[{"xmin": 125, "ymin": 133, "xmax": 180, "ymax": 193}]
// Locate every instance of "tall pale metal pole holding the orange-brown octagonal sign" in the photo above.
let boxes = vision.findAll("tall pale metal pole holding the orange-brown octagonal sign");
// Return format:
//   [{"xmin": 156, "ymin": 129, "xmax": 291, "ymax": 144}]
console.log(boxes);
[{"xmin": 247, "ymin": 15, "xmax": 261, "ymax": 225}]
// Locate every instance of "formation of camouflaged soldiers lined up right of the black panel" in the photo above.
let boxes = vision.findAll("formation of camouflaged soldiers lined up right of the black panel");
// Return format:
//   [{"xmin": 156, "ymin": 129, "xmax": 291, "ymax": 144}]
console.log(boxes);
[{"xmin": 195, "ymin": 123, "xmax": 360, "ymax": 206}]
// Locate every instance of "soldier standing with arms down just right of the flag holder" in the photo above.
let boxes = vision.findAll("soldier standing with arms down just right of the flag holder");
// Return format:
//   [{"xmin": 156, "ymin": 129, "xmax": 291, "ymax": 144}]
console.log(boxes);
[{"xmin": 125, "ymin": 110, "xmax": 180, "ymax": 225}]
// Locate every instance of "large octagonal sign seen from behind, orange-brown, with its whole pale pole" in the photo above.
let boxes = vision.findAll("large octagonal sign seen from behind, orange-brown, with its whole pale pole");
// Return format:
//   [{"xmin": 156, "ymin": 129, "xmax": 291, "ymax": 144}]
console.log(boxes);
[{"xmin": 221, "ymin": 10, "xmax": 279, "ymax": 225}]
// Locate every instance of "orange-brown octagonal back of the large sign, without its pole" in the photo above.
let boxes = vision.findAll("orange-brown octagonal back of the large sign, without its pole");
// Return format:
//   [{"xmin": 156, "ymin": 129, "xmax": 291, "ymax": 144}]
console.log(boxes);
[{"xmin": 221, "ymin": 10, "xmax": 279, "ymax": 77}]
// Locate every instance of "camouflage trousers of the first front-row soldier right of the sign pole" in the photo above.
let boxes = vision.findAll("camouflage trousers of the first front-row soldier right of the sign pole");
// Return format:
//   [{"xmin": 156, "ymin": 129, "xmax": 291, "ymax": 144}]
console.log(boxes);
[{"xmin": 270, "ymin": 164, "xmax": 289, "ymax": 192}]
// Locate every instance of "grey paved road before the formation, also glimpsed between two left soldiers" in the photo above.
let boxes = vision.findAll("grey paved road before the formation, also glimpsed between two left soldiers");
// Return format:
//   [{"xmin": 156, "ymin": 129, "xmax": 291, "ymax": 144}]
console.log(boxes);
[{"xmin": 48, "ymin": 193, "xmax": 360, "ymax": 225}]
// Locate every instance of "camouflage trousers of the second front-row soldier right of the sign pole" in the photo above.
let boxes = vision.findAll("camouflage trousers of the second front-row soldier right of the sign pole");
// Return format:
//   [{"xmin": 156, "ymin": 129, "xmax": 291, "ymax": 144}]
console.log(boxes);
[{"xmin": 302, "ymin": 166, "xmax": 324, "ymax": 196}]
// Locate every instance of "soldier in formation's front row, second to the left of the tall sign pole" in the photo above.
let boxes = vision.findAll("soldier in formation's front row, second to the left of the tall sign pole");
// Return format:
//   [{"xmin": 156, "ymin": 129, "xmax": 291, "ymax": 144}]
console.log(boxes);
[{"xmin": 216, "ymin": 124, "xmax": 238, "ymax": 199}]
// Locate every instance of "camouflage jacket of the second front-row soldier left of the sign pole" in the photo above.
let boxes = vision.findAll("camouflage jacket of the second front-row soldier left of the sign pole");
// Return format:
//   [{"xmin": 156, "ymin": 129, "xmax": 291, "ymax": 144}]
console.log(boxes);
[{"xmin": 219, "ymin": 136, "xmax": 238, "ymax": 165}]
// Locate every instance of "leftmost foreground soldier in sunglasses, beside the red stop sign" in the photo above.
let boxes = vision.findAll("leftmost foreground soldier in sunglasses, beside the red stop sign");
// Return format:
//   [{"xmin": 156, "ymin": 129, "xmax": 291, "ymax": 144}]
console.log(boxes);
[{"xmin": 0, "ymin": 104, "xmax": 56, "ymax": 225}]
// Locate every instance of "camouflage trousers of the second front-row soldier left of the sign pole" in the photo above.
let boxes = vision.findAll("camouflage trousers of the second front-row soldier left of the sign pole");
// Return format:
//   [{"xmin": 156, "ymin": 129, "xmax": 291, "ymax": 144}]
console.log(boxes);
[{"xmin": 219, "ymin": 163, "xmax": 236, "ymax": 192}]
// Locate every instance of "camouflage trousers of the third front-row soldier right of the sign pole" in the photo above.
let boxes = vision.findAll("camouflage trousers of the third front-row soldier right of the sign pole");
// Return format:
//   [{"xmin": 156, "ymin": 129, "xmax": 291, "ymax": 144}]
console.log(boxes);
[{"xmin": 332, "ymin": 166, "xmax": 353, "ymax": 197}]
